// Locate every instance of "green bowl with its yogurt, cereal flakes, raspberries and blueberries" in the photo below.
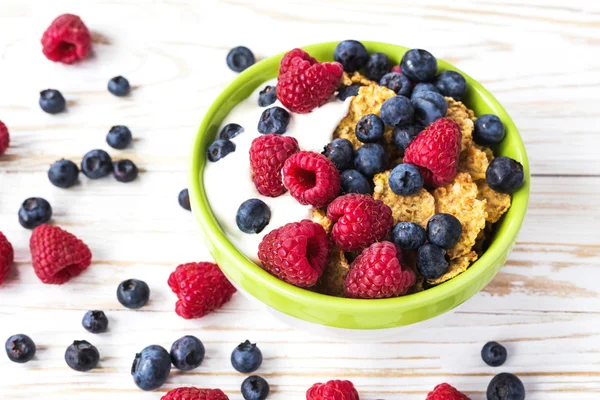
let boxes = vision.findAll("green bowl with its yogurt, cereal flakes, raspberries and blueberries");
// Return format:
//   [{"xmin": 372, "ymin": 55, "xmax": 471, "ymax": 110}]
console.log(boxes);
[{"xmin": 190, "ymin": 40, "xmax": 529, "ymax": 338}]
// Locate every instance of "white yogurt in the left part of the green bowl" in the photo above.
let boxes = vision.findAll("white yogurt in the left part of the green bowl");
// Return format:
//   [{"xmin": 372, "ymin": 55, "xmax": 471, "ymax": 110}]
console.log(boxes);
[{"xmin": 204, "ymin": 80, "xmax": 352, "ymax": 262}]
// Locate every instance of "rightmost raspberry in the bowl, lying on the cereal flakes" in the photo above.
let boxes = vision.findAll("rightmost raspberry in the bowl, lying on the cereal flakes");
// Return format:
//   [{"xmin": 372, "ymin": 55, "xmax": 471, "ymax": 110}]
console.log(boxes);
[{"xmin": 404, "ymin": 118, "xmax": 461, "ymax": 187}]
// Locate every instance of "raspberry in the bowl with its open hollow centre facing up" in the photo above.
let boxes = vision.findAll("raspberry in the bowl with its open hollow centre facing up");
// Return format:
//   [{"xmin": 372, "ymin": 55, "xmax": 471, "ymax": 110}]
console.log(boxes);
[{"xmin": 282, "ymin": 151, "xmax": 342, "ymax": 208}]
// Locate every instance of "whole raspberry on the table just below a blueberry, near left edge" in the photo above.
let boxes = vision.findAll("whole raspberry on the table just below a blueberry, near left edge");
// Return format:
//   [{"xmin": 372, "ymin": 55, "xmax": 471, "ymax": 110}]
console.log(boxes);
[{"xmin": 29, "ymin": 224, "xmax": 92, "ymax": 285}]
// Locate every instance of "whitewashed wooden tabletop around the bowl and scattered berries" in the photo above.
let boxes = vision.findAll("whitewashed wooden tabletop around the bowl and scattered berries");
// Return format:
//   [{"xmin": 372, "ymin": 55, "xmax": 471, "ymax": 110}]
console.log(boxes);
[{"xmin": 0, "ymin": 0, "xmax": 600, "ymax": 400}]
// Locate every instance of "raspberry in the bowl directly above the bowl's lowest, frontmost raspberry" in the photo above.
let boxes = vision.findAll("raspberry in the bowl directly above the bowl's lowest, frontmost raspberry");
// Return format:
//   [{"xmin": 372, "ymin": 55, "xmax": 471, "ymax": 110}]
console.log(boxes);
[{"xmin": 327, "ymin": 193, "xmax": 394, "ymax": 251}]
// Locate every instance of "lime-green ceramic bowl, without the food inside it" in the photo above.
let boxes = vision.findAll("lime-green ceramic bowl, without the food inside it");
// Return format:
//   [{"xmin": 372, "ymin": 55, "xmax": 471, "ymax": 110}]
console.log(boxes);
[{"xmin": 189, "ymin": 42, "xmax": 530, "ymax": 330}]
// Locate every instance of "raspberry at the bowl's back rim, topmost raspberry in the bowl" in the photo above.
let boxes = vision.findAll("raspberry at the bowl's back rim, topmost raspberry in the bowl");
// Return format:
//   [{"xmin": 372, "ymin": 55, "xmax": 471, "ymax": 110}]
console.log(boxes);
[{"xmin": 276, "ymin": 49, "xmax": 344, "ymax": 114}]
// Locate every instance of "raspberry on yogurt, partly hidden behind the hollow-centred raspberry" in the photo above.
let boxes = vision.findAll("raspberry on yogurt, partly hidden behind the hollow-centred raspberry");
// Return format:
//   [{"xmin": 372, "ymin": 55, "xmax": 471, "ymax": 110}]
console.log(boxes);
[{"xmin": 250, "ymin": 133, "xmax": 300, "ymax": 197}]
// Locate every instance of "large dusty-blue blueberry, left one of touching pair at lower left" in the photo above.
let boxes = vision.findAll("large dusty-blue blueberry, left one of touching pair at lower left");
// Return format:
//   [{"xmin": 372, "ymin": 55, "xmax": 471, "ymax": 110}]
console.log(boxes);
[{"xmin": 131, "ymin": 345, "xmax": 171, "ymax": 390}]
